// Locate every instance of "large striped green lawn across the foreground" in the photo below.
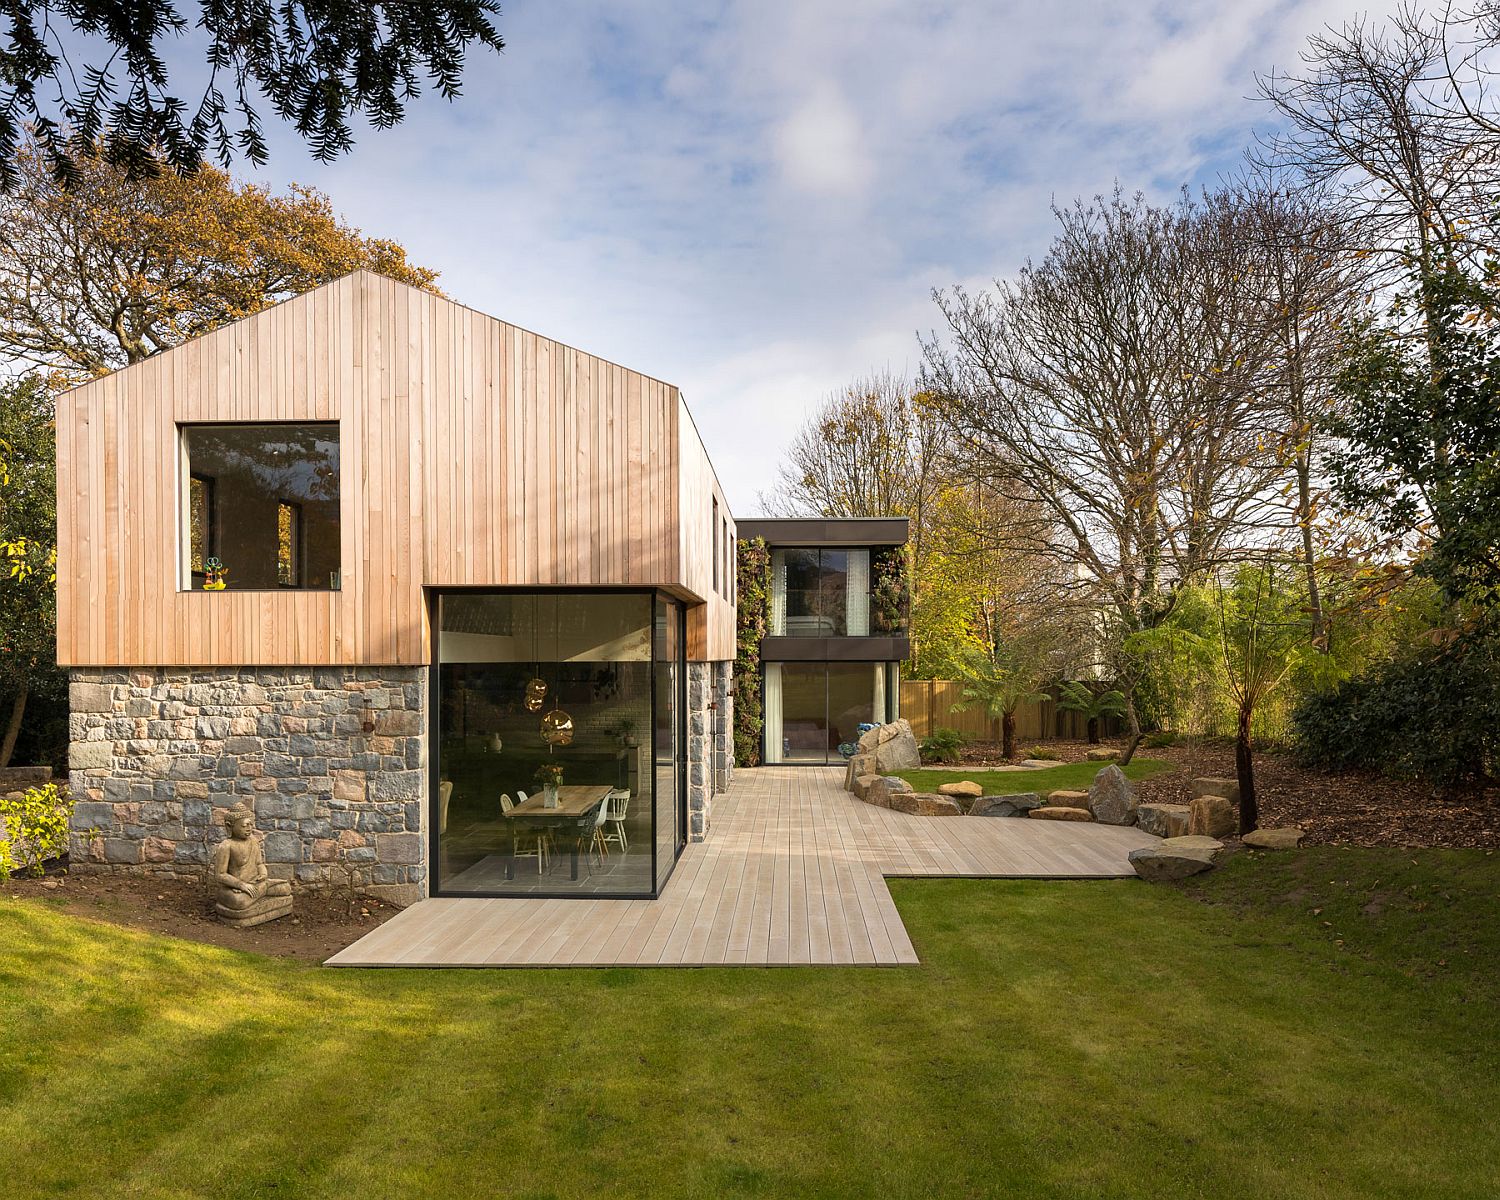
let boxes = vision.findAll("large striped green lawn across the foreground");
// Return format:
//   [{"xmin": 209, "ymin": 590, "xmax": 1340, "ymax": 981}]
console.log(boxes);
[{"xmin": 0, "ymin": 849, "xmax": 1500, "ymax": 1200}]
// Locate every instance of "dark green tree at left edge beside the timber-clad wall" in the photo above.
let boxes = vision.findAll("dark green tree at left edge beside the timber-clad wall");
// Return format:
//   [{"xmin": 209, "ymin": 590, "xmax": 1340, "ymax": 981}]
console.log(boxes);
[{"xmin": 0, "ymin": 375, "xmax": 63, "ymax": 767}]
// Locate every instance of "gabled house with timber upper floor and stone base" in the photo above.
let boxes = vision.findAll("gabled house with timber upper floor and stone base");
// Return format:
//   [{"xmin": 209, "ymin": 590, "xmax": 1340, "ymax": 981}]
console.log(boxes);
[{"xmin": 57, "ymin": 272, "xmax": 738, "ymax": 902}]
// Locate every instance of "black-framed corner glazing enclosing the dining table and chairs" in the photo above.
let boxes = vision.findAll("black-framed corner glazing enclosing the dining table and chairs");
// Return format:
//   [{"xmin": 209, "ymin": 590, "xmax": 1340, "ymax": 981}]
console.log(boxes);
[{"xmin": 432, "ymin": 591, "xmax": 684, "ymax": 897}]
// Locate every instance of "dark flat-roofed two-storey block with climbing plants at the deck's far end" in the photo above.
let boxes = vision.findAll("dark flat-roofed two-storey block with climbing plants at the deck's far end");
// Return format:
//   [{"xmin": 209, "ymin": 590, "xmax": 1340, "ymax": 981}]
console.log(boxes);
[{"xmin": 738, "ymin": 518, "xmax": 911, "ymax": 764}]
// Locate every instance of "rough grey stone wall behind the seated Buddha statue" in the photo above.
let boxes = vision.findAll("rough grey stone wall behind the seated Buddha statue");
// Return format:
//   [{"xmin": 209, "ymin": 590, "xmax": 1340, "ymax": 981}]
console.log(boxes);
[{"xmin": 69, "ymin": 668, "xmax": 428, "ymax": 903}]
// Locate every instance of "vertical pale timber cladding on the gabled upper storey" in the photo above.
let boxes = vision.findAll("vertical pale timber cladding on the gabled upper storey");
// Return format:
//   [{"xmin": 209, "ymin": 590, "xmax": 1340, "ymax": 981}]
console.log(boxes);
[{"xmin": 57, "ymin": 272, "xmax": 734, "ymax": 666}]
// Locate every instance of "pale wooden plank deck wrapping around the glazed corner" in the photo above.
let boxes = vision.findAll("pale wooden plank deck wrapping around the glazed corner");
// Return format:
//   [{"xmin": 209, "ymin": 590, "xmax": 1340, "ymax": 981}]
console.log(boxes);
[{"xmin": 327, "ymin": 767, "xmax": 1157, "ymax": 966}]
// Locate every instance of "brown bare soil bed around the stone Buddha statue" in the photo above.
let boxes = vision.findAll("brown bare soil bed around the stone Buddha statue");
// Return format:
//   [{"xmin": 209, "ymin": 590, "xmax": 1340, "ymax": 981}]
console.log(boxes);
[{"xmin": 0, "ymin": 873, "xmax": 401, "ymax": 963}]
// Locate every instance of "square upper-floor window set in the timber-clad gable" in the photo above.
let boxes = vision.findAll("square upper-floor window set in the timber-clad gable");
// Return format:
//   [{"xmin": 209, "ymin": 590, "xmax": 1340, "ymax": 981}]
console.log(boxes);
[{"xmin": 182, "ymin": 422, "xmax": 339, "ymax": 591}]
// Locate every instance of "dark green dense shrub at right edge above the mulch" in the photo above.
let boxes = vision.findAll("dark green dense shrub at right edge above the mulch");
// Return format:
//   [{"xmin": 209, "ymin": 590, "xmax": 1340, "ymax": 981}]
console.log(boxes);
[{"xmin": 1292, "ymin": 633, "xmax": 1500, "ymax": 788}]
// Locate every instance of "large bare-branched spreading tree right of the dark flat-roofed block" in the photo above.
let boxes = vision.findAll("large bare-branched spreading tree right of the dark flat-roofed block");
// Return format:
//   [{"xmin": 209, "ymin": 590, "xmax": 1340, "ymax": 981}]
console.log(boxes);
[{"xmin": 924, "ymin": 192, "xmax": 1281, "ymax": 761}]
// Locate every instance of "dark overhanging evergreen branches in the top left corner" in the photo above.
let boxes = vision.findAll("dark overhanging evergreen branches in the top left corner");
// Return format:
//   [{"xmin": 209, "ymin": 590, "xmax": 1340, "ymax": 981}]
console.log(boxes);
[{"xmin": 0, "ymin": 0, "xmax": 504, "ymax": 191}]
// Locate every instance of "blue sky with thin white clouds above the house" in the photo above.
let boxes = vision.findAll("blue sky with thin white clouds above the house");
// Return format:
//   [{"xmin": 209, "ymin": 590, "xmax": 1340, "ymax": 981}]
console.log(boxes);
[{"xmin": 237, "ymin": 0, "xmax": 1380, "ymax": 516}]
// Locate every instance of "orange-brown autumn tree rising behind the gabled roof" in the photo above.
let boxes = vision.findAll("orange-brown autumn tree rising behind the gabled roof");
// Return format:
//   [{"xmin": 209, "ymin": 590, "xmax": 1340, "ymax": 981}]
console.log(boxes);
[{"xmin": 0, "ymin": 135, "xmax": 437, "ymax": 383}]
